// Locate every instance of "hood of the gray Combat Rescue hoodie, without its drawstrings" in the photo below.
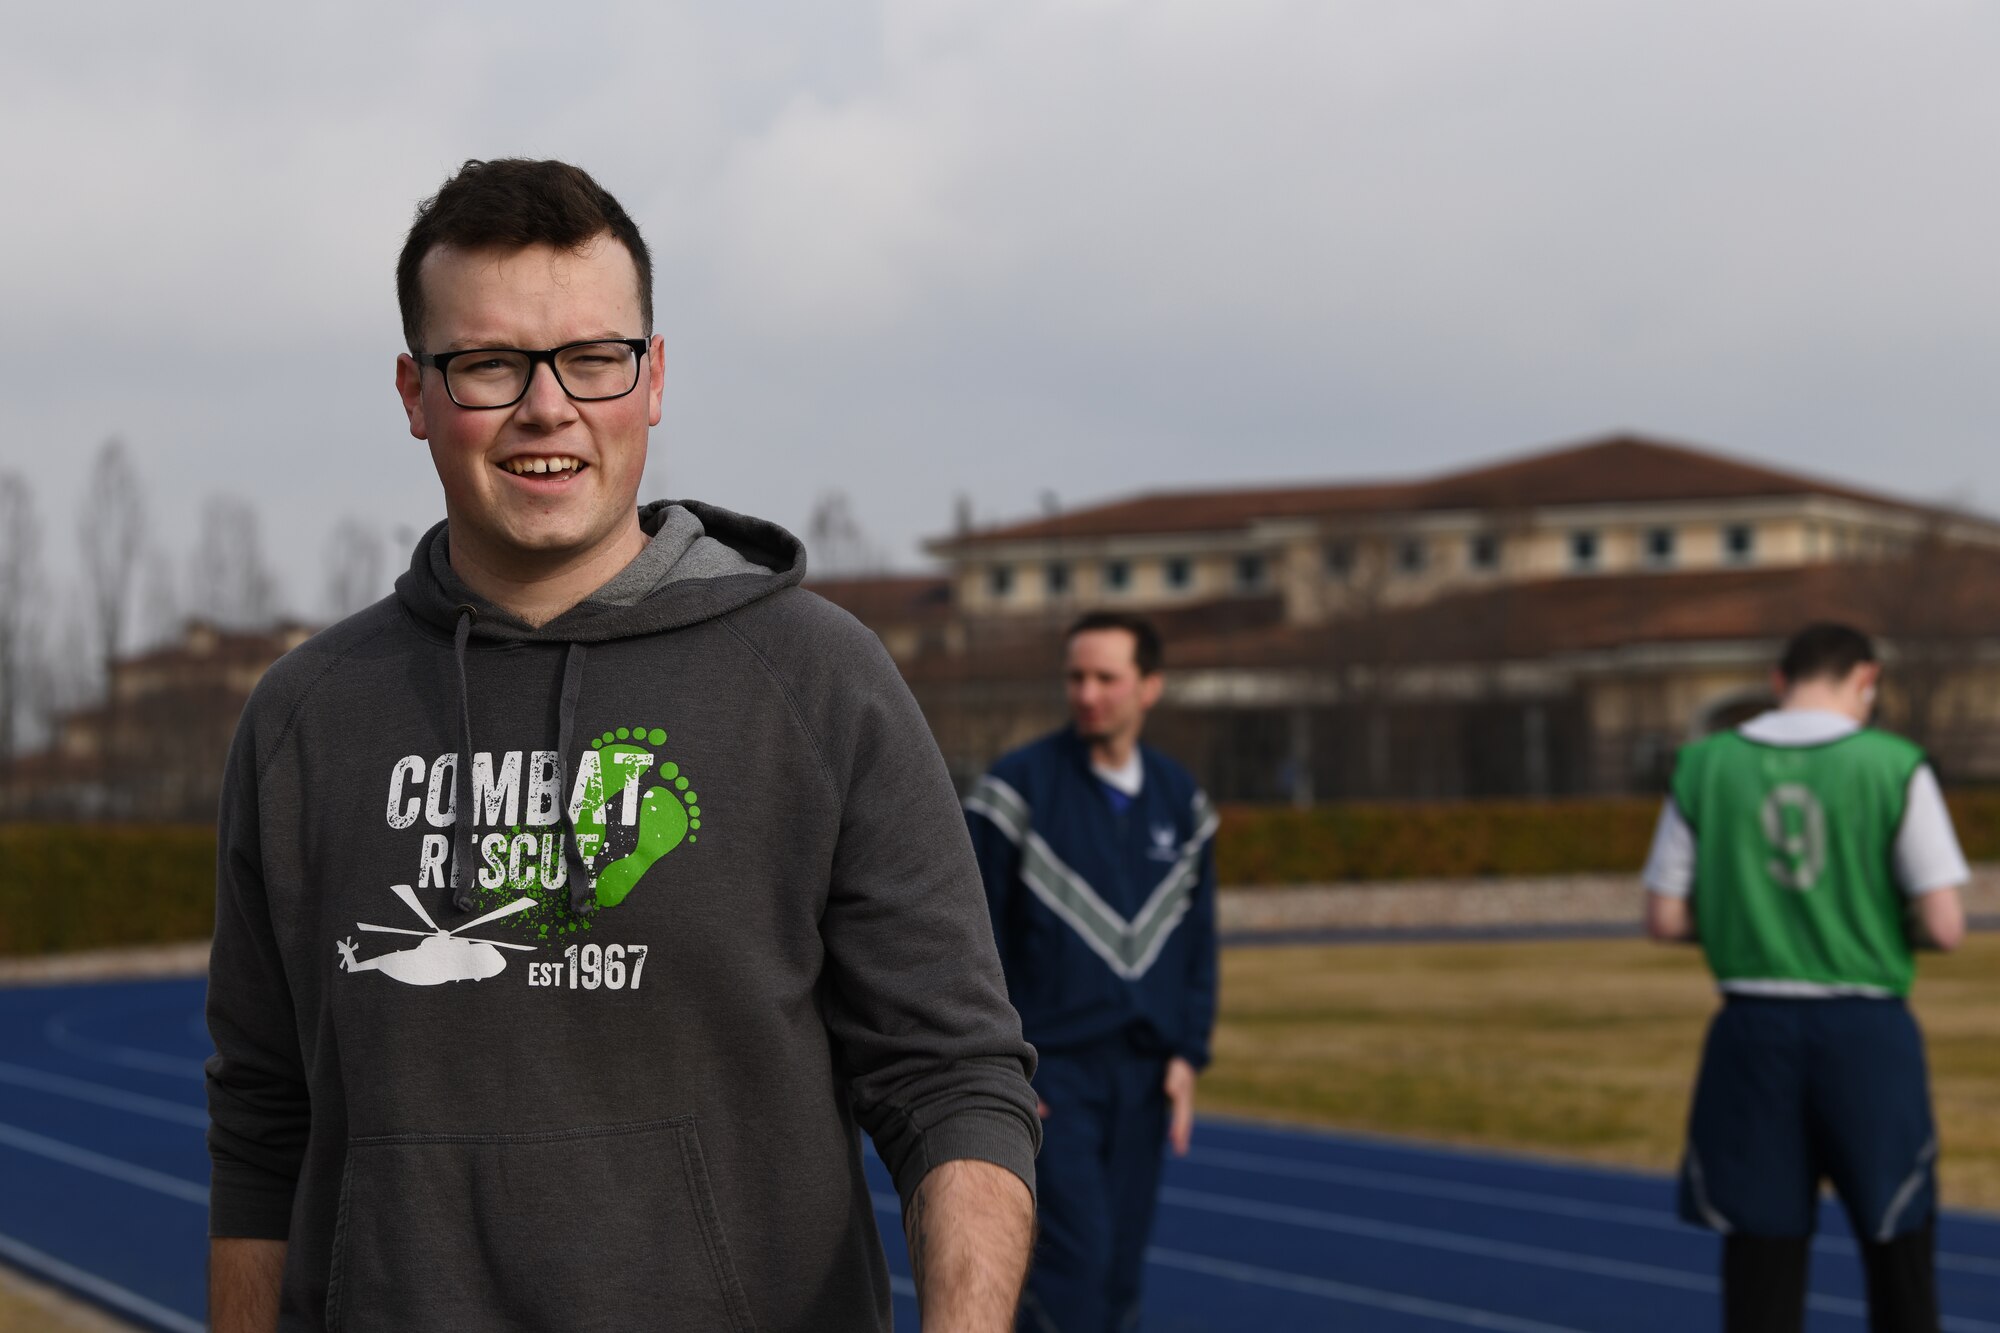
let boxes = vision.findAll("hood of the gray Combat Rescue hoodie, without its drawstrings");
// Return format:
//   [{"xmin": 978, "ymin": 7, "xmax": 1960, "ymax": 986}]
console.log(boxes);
[{"xmin": 396, "ymin": 500, "xmax": 806, "ymax": 642}]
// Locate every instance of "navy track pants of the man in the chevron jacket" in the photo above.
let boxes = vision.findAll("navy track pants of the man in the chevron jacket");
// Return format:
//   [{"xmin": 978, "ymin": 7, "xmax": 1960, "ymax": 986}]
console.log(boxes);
[{"xmin": 1018, "ymin": 1035, "xmax": 1168, "ymax": 1333}]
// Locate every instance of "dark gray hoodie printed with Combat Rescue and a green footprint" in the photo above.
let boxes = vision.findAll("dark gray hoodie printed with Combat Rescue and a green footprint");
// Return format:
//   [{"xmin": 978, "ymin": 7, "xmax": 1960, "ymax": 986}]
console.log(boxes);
[{"xmin": 208, "ymin": 502, "xmax": 1038, "ymax": 1333}]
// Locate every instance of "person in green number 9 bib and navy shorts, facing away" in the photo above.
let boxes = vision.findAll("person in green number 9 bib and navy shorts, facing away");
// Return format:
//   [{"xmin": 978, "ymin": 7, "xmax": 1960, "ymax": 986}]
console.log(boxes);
[{"xmin": 1646, "ymin": 624, "xmax": 1970, "ymax": 1333}]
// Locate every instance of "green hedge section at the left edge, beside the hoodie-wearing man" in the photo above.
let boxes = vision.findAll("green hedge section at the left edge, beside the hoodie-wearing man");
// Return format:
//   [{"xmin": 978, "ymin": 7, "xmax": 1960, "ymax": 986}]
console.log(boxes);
[{"xmin": 0, "ymin": 823, "xmax": 216, "ymax": 957}]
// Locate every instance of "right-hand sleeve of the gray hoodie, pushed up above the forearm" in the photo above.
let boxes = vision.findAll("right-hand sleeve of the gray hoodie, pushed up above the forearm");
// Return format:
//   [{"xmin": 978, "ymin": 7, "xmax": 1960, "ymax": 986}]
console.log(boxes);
[{"xmin": 800, "ymin": 624, "xmax": 1040, "ymax": 1203}]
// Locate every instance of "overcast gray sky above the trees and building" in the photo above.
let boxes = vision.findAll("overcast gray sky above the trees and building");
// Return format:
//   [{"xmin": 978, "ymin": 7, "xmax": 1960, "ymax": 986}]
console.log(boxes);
[{"xmin": 0, "ymin": 0, "xmax": 2000, "ymax": 632}]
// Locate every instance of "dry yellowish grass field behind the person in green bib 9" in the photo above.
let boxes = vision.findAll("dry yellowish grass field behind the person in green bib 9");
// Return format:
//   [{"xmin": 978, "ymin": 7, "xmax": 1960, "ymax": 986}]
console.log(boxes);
[{"xmin": 1202, "ymin": 935, "xmax": 2000, "ymax": 1209}]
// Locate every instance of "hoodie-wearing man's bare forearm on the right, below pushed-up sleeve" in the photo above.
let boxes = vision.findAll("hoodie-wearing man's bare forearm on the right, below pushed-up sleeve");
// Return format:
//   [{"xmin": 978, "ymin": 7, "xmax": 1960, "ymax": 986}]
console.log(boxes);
[{"xmin": 904, "ymin": 1159, "xmax": 1034, "ymax": 1333}]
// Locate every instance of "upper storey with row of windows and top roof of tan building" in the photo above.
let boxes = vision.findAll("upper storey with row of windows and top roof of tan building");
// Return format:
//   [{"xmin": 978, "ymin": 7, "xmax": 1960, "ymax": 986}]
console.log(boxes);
[{"xmin": 930, "ymin": 436, "xmax": 2000, "ymax": 624}]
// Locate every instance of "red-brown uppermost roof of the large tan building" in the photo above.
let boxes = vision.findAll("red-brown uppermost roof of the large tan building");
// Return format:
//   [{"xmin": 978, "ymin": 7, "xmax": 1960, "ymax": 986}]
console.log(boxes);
[{"xmin": 932, "ymin": 434, "xmax": 1930, "ymax": 554}]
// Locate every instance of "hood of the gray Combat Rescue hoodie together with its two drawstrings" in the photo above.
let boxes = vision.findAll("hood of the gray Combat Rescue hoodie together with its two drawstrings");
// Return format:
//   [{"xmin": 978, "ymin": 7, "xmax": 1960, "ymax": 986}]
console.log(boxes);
[{"xmin": 396, "ymin": 500, "xmax": 806, "ymax": 913}]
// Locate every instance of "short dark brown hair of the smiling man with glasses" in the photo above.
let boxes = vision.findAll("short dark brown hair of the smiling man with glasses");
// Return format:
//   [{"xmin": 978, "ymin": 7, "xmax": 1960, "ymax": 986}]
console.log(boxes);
[{"xmin": 396, "ymin": 158, "xmax": 652, "ymax": 354}]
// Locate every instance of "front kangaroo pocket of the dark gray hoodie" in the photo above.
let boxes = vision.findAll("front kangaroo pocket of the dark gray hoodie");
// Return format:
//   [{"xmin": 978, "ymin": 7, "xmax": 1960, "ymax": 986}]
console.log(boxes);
[{"xmin": 326, "ymin": 1115, "xmax": 756, "ymax": 1333}]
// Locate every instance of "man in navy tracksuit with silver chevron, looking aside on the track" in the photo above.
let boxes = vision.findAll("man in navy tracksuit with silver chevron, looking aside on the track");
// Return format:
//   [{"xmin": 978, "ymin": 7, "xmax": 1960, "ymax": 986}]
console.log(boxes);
[{"xmin": 966, "ymin": 612, "xmax": 1216, "ymax": 1333}]
